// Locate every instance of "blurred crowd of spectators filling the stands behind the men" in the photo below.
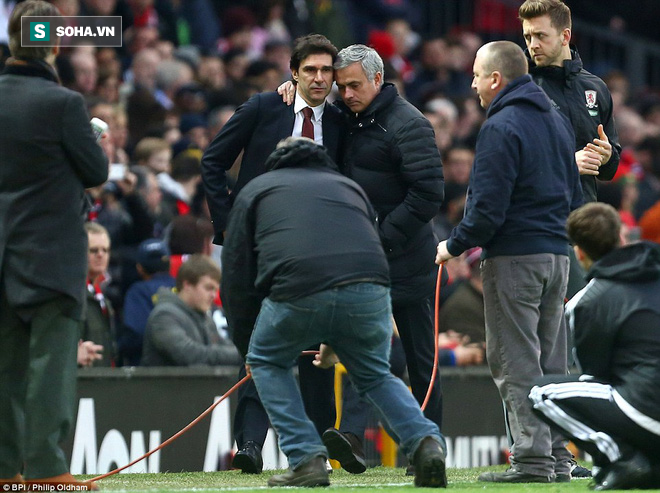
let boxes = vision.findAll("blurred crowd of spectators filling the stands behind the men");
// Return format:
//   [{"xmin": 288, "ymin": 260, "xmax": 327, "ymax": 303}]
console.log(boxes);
[{"xmin": 0, "ymin": 0, "xmax": 660, "ymax": 366}]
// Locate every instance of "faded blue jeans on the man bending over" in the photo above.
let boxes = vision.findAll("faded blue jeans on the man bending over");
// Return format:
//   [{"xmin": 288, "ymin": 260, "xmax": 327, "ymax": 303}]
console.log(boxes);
[{"xmin": 247, "ymin": 283, "xmax": 446, "ymax": 469}]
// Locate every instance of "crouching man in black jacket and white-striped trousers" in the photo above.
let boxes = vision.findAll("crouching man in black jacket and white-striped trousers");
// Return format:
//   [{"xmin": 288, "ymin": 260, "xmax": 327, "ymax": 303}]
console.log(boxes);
[{"xmin": 529, "ymin": 203, "xmax": 660, "ymax": 490}]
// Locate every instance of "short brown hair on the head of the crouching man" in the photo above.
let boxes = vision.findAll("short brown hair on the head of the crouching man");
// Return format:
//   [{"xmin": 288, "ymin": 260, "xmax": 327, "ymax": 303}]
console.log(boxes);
[{"xmin": 566, "ymin": 202, "xmax": 621, "ymax": 262}]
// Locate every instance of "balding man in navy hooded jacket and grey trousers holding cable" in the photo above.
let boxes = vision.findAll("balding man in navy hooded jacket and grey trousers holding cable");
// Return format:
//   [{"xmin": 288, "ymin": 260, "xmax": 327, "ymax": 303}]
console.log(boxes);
[{"xmin": 436, "ymin": 41, "xmax": 582, "ymax": 483}]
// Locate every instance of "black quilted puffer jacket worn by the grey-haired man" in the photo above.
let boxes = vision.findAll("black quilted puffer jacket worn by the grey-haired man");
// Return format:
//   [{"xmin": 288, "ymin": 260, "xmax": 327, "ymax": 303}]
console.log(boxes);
[{"xmin": 337, "ymin": 83, "xmax": 444, "ymax": 303}]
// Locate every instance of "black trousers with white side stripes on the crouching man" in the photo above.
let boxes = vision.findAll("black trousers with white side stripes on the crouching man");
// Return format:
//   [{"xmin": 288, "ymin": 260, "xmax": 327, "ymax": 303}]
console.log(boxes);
[{"xmin": 530, "ymin": 375, "xmax": 660, "ymax": 468}]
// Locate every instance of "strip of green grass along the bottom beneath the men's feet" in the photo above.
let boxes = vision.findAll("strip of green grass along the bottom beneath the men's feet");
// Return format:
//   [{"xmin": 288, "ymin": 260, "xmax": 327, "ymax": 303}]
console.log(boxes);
[{"xmin": 85, "ymin": 466, "xmax": 590, "ymax": 493}]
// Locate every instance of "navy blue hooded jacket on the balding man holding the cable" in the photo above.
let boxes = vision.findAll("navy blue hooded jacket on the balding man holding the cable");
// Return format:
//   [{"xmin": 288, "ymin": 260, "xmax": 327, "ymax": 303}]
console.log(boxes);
[{"xmin": 447, "ymin": 75, "xmax": 582, "ymax": 258}]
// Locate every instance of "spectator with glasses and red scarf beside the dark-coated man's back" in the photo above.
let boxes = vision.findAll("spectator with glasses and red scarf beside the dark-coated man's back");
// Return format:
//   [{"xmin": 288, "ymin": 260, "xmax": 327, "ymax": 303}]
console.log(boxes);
[{"xmin": 81, "ymin": 223, "xmax": 116, "ymax": 366}]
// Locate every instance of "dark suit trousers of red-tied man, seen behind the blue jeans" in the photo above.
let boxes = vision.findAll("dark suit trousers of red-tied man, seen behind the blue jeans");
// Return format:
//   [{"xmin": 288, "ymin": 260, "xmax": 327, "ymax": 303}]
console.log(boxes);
[{"xmin": 234, "ymin": 356, "xmax": 336, "ymax": 449}]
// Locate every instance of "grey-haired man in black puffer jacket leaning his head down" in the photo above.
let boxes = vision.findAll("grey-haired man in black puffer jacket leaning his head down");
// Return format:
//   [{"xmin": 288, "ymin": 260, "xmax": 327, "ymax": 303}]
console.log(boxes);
[{"xmin": 330, "ymin": 45, "xmax": 444, "ymax": 462}]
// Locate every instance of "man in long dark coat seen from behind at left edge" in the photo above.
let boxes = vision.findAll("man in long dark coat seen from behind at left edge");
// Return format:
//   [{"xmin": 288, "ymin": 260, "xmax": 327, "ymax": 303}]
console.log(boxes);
[{"xmin": 0, "ymin": 0, "xmax": 108, "ymax": 487}]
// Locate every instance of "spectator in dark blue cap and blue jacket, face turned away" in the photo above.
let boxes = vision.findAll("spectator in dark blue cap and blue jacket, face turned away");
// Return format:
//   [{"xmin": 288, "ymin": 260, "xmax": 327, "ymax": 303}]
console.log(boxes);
[{"xmin": 118, "ymin": 239, "xmax": 175, "ymax": 366}]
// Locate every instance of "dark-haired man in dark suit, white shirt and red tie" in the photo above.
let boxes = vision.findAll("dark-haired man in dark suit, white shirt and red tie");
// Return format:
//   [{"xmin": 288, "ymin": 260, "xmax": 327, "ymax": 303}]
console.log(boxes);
[{"xmin": 202, "ymin": 34, "xmax": 343, "ymax": 473}]
